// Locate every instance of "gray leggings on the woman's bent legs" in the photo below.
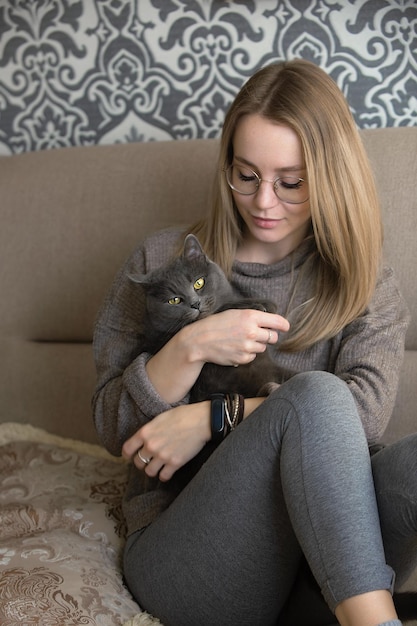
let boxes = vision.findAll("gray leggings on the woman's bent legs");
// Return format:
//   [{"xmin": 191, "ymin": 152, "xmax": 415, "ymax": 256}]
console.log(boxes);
[{"xmin": 125, "ymin": 372, "xmax": 417, "ymax": 626}]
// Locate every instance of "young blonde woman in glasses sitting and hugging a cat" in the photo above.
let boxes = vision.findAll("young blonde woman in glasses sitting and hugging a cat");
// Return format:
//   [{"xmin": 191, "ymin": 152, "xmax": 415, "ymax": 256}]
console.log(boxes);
[{"xmin": 94, "ymin": 61, "xmax": 417, "ymax": 626}]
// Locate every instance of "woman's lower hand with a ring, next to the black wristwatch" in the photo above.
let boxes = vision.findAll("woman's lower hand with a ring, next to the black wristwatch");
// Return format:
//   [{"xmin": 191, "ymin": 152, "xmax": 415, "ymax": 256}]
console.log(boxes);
[{"xmin": 122, "ymin": 402, "xmax": 211, "ymax": 481}]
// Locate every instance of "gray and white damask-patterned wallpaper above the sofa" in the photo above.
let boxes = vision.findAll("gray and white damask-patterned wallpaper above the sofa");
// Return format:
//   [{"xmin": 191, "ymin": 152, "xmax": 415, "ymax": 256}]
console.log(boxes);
[{"xmin": 0, "ymin": 0, "xmax": 417, "ymax": 154}]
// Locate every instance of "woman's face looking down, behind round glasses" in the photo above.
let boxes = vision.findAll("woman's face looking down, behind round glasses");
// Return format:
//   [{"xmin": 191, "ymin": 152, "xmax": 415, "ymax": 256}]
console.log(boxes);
[{"xmin": 232, "ymin": 114, "xmax": 310, "ymax": 264}]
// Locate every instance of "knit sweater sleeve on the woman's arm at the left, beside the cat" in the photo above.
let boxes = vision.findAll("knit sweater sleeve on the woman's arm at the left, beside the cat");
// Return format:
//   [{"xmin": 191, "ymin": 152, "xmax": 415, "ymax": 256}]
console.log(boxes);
[{"xmin": 92, "ymin": 232, "xmax": 188, "ymax": 456}]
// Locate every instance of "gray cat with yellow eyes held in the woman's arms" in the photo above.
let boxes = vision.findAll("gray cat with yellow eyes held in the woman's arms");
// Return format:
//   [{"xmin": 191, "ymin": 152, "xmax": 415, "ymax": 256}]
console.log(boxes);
[{"xmin": 129, "ymin": 235, "xmax": 278, "ymax": 402}]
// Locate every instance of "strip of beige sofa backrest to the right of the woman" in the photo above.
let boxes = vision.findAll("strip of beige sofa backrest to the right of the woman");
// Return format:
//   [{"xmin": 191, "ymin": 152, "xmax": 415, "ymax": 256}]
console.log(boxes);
[{"xmin": 362, "ymin": 127, "xmax": 417, "ymax": 441}]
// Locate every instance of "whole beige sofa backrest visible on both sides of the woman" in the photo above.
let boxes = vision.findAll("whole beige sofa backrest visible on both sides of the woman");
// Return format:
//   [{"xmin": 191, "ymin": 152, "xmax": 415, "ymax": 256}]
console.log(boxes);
[{"xmin": 0, "ymin": 128, "xmax": 417, "ymax": 441}]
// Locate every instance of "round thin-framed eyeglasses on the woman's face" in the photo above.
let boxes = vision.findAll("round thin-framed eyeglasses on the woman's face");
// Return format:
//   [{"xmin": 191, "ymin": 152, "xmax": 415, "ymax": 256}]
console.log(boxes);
[{"xmin": 225, "ymin": 165, "xmax": 308, "ymax": 204}]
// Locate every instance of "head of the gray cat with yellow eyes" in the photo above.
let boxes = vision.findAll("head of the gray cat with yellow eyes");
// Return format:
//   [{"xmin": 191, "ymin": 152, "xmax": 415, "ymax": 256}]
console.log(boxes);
[{"xmin": 130, "ymin": 235, "xmax": 232, "ymax": 332}]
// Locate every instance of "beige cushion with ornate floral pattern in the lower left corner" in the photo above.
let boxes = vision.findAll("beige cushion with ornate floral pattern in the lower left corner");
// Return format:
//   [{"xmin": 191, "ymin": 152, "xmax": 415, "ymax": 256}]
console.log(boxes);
[{"xmin": 0, "ymin": 424, "xmax": 160, "ymax": 626}]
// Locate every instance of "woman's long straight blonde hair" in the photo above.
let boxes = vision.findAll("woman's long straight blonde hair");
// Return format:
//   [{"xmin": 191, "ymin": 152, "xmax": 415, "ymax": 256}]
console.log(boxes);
[{"xmin": 191, "ymin": 60, "xmax": 382, "ymax": 351}]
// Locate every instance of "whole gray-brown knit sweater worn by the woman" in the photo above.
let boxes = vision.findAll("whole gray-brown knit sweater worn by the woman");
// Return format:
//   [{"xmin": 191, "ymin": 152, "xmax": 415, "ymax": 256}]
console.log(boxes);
[{"xmin": 93, "ymin": 230, "xmax": 409, "ymax": 533}]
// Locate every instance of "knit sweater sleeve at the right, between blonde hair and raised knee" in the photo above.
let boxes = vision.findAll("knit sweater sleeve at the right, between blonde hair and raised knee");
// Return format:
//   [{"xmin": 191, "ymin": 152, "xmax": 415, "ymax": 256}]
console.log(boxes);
[{"xmin": 334, "ymin": 268, "xmax": 410, "ymax": 445}]
